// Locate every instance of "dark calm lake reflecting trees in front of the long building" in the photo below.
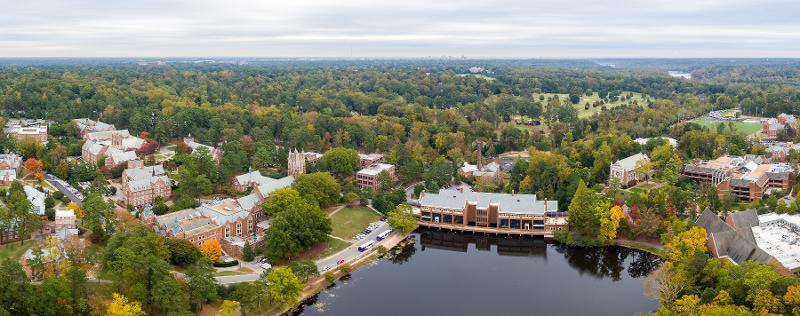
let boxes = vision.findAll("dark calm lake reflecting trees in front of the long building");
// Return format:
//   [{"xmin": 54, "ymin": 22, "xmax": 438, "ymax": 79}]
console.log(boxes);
[{"xmin": 297, "ymin": 230, "xmax": 660, "ymax": 316}]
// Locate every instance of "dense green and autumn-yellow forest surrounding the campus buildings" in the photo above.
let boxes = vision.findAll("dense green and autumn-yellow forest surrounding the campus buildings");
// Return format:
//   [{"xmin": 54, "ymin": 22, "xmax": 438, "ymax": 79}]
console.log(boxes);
[{"xmin": 0, "ymin": 59, "xmax": 800, "ymax": 314}]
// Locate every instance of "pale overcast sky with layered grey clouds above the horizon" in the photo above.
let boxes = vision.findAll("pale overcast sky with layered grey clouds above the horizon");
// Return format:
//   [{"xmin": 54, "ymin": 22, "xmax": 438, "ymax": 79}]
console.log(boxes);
[{"xmin": 0, "ymin": 0, "xmax": 800, "ymax": 58}]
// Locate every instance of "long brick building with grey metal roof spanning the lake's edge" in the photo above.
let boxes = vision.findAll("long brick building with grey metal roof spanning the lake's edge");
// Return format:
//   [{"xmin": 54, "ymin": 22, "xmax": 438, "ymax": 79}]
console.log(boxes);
[{"xmin": 417, "ymin": 189, "xmax": 568, "ymax": 237}]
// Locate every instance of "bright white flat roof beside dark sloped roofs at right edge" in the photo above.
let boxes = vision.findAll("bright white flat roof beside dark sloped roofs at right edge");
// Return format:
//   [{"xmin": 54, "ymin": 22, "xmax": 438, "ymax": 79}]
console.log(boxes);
[{"xmin": 752, "ymin": 213, "xmax": 800, "ymax": 271}]
